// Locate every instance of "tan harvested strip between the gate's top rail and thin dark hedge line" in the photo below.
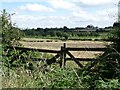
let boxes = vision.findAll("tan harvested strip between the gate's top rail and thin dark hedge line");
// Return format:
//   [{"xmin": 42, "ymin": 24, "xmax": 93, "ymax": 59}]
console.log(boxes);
[{"xmin": 21, "ymin": 41, "xmax": 109, "ymax": 50}]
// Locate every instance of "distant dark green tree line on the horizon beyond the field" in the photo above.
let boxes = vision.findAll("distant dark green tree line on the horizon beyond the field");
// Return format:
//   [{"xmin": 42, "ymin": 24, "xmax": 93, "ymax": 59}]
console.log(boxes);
[{"xmin": 22, "ymin": 26, "xmax": 112, "ymax": 39}]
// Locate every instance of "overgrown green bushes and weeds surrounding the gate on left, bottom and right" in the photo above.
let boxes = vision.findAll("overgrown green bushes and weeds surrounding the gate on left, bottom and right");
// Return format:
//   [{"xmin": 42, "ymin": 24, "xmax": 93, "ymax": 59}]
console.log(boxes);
[{"xmin": 0, "ymin": 10, "xmax": 120, "ymax": 89}]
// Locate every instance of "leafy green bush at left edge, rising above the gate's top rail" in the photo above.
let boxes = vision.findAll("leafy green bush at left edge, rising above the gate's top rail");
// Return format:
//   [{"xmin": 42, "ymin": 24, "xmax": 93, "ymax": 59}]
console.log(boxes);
[{"xmin": 0, "ymin": 9, "xmax": 22, "ymax": 47}]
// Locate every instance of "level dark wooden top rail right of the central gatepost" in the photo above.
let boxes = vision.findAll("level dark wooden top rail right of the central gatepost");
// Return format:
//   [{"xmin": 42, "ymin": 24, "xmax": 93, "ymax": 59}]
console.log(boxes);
[{"xmin": 67, "ymin": 47, "xmax": 106, "ymax": 51}]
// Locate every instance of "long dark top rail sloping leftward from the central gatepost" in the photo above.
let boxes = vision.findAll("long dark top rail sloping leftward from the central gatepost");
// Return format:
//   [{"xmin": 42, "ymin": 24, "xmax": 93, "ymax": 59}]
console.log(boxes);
[{"xmin": 7, "ymin": 47, "xmax": 60, "ymax": 53}]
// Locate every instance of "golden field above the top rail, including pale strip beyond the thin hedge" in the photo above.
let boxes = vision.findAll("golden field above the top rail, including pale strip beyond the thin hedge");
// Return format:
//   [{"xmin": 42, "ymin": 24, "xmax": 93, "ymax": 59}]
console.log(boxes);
[{"xmin": 20, "ymin": 38, "xmax": 109, "ymax": 50}]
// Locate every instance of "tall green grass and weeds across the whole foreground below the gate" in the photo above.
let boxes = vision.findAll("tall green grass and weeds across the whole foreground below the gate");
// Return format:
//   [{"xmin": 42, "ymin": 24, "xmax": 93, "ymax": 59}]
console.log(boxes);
[{"xmin": 2, "ymin": 61, "xmax": 120, "ymax": 90}]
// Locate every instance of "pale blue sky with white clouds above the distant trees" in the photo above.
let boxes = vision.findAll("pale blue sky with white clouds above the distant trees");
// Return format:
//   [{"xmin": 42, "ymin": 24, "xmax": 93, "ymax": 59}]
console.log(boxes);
[{"xmin": 0, "ymin": 0, "xmax": 118, "ymax": 28}]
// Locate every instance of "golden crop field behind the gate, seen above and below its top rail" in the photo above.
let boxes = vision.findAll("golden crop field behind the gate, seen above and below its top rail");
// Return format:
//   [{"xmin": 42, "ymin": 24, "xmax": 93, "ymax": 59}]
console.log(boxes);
[{"xmin": 20, "ymin": 38, "xmax": 109, "ymax": 58}]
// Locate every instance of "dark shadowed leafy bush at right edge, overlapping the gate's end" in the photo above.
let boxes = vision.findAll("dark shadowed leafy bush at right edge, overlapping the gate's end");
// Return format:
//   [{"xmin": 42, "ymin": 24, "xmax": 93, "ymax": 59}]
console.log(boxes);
[{"xmin": 83, "ymin": 22, "xmax": 120, "ymax": 82}]
